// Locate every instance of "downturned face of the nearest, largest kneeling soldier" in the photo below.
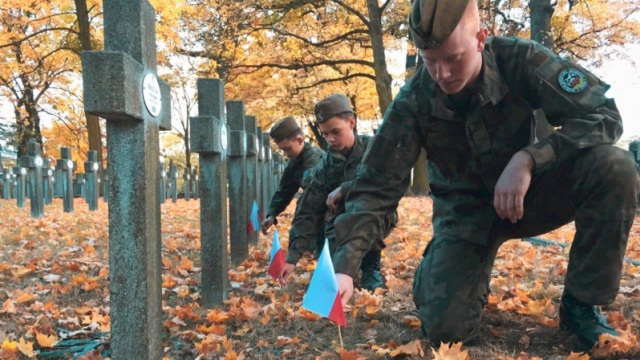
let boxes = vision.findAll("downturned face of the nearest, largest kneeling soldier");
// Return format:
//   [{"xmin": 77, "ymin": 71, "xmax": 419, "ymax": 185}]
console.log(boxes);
[{"xmin": 419, "ymin": 23, "xmax": 488, "ymax": 94}]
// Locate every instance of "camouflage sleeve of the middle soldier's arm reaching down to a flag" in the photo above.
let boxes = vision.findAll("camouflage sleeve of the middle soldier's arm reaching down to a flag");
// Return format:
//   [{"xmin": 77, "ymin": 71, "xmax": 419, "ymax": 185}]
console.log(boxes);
[{"xmin": 286, "ymin": 163, "xmax": 329, "ymax": 264}]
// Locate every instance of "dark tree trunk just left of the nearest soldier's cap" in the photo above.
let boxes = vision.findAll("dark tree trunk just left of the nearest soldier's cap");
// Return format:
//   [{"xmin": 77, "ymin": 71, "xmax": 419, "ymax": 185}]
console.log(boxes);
[{"xmin": 367, "ymin": 0, "xmax": 391, "ymax": 115}]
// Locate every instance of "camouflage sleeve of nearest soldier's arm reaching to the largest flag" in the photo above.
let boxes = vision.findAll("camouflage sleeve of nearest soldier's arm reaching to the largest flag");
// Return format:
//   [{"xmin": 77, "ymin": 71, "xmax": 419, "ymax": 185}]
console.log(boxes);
[{"xmin": 333, "ymin": 101, "xmax": 421, "ymax": 277}]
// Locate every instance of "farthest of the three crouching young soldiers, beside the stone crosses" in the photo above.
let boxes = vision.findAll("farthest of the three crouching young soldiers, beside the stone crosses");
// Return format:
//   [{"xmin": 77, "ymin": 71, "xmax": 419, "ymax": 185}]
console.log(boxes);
[{"xmin": 260, "ymin": 116, "xmax": 324, "ymax": 247}]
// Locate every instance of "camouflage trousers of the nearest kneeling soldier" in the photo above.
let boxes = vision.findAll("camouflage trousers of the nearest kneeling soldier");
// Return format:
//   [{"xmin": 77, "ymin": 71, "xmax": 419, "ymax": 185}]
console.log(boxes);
[{"xmin": 413, "ymin": 145, "xmax": 639, "ymax": 342}]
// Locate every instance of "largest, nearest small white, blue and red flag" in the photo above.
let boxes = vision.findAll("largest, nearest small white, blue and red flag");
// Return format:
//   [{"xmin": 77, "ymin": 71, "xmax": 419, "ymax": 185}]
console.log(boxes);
[{"xmin": 302, "ymin": 240, "xmax": 347, "ymax": 327}]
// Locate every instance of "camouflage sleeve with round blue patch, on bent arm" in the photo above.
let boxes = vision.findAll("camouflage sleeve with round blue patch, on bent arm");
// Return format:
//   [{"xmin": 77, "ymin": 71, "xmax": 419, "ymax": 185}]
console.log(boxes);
[{"xmin": 524, "ymin": 44, "xmax": 622, "ymax": 173}]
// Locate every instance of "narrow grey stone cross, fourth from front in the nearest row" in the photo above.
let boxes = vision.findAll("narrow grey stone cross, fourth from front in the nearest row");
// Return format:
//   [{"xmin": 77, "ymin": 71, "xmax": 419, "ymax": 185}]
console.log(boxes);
[{"xmin": 245, "ymin": 115, "xmax": 260, "ymax": 245}]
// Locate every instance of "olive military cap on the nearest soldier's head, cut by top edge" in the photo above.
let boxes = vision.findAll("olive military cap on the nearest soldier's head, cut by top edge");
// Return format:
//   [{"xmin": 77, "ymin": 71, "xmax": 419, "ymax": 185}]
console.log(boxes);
[{"xmin": 409, "ymin": 0, "xmax": 475, "ymax": 50}]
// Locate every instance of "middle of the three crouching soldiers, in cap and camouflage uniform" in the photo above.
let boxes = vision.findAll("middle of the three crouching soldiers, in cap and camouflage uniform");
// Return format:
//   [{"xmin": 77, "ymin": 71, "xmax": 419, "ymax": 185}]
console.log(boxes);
[{"xmin": 282, "ymin": 94, "xmax": 396, "ymax": 290}]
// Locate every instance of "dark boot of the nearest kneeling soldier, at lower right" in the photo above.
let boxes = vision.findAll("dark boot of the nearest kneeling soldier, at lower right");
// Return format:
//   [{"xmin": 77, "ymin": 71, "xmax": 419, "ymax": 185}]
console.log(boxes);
[{"xmin": 560, "ymin": 294, "xmax": 617, "ymax": 349}]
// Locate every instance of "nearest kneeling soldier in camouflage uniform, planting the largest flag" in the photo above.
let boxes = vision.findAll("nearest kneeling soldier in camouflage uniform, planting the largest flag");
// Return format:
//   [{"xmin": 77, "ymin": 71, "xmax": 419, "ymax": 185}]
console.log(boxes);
[{"xmin": 333, "ymin": 0, "xmax": 639, "ymax": 348}]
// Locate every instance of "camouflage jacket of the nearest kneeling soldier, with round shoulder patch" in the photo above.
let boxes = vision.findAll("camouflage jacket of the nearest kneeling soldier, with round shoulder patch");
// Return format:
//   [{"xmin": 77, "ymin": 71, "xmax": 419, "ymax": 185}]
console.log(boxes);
[{"xmin": 333, "ymin": 37, "xmax": 622, "ymax": 276}]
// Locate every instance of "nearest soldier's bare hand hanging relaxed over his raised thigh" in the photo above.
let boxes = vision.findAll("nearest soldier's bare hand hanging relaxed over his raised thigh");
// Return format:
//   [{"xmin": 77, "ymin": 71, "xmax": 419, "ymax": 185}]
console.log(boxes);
[{"xmin": 493, "ymin": 151, "xmax": 535, "ymax": 224}]
